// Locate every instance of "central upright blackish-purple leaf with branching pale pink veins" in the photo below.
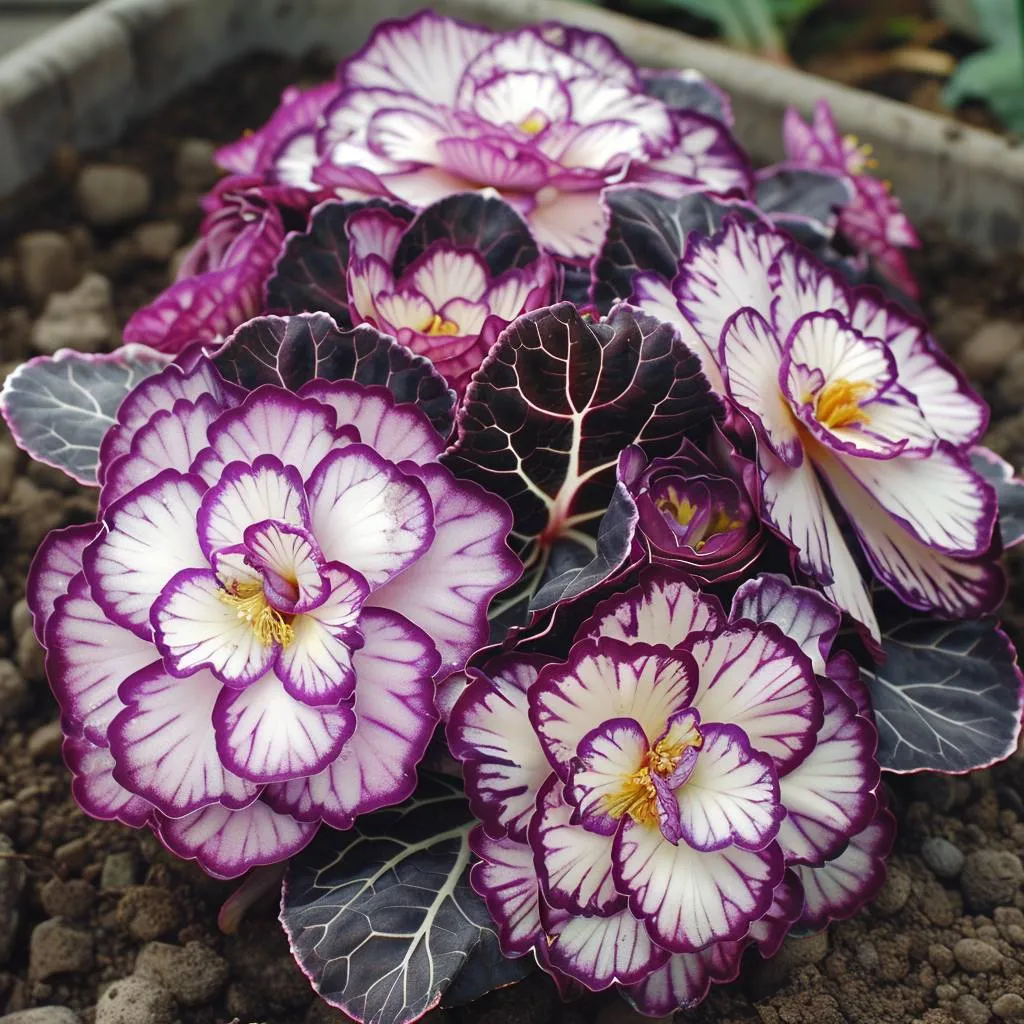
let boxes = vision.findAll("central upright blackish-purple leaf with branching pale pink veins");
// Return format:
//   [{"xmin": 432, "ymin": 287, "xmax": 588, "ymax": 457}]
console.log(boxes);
[{"xmin": 442, "ymin": 302, "xmax": 720, "ymax": 623}]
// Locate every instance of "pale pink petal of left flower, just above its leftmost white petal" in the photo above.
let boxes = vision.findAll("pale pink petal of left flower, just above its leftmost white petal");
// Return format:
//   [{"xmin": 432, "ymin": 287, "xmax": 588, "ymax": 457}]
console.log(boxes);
[{"xmin": 99, "ymin": 394, "xmax": 223, "ymax": 508}]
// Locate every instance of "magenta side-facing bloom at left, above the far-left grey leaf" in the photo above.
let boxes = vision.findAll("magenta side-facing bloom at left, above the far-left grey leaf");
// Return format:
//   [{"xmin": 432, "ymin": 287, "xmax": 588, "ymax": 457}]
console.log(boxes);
[{"xmin": 124, "ymin": 177, "xmax": 285, "ymax": 353}]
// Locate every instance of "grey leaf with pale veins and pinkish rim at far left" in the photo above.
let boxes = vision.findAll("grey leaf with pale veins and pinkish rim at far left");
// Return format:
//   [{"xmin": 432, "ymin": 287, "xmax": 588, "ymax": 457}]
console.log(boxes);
[{"xmin": 0, "ymin": 345, "xmax": 168, "ymax": 486}]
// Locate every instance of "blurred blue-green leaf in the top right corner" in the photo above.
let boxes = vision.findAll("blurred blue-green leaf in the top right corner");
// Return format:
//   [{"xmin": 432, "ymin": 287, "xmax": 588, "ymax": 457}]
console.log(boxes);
[{"xmin": 942, "ymin": 0, "xmax": 1024, "ymax": 133}]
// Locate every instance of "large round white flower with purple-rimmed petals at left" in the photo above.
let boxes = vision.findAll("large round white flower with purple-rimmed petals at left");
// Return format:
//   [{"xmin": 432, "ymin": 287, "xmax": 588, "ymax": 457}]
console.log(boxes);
[{"xmin": 29, "ymin": 357, "xmax": 519, "ymax": 878}]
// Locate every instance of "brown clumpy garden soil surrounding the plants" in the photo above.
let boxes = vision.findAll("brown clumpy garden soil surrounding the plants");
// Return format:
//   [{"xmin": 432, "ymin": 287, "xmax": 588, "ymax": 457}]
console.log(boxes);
[{"xmin": 0, "ymin": 51, "xmax": 1024, "ymax": 1024}]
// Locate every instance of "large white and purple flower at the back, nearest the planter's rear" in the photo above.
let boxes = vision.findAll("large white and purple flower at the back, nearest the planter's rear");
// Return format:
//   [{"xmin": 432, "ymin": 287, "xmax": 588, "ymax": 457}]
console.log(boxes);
[{"xmin": 264, "ymin": 12, "xmax": 752, "ymax": 259}]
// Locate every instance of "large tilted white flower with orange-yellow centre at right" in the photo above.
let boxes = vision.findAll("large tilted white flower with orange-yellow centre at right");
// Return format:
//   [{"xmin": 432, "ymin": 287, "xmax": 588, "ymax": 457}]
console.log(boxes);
[{"xmin": 634, "ymin": 219, "xmax": 1004, "ymax": 636}]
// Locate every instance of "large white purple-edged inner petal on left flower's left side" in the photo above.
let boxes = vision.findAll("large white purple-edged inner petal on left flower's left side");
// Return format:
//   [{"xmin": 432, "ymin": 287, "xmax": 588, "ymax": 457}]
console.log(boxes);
[{"xmin": 82, "ymin": 469, "xmax": 207, "ymax": 639}]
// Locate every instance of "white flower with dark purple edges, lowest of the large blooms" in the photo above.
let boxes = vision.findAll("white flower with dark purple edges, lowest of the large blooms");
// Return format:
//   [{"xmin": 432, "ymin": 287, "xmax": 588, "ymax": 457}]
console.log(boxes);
[{"xmin": 447, "ymin": 568, "xmax": 892, "ymax": 1016}]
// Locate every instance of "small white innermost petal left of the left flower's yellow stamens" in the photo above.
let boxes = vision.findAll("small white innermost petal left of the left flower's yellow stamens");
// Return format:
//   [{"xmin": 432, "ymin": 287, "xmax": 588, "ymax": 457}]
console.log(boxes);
[{"xmin": 152, "ymin": 569, "xmax": 274, "ymax": 686}]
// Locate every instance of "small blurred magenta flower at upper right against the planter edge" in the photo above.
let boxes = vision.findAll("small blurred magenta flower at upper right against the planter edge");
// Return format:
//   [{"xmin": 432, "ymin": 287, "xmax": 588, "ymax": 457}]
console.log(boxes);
[{"xmin": 782, "ymin": 99, "xmax": 921, "ymax": 299}]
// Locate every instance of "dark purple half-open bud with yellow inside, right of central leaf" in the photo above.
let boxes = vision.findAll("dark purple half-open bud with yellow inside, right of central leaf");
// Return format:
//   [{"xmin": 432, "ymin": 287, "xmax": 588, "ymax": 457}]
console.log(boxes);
[{"xmin": 618, "ymin": 430, "xmax": 765, "ymax": 583}]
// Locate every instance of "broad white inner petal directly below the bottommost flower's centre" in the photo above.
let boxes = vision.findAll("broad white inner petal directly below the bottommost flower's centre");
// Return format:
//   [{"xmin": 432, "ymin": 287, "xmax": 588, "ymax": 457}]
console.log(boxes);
[{"xmin": 612, "ymin": 821, "xmax": 785, "ymax": 953}]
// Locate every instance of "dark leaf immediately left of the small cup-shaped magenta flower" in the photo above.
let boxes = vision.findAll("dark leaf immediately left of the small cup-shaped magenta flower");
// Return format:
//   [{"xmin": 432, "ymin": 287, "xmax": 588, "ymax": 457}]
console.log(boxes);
[{"xmin": 266, "ymin": 200, "xmax": 413, "ymax": 328}]
